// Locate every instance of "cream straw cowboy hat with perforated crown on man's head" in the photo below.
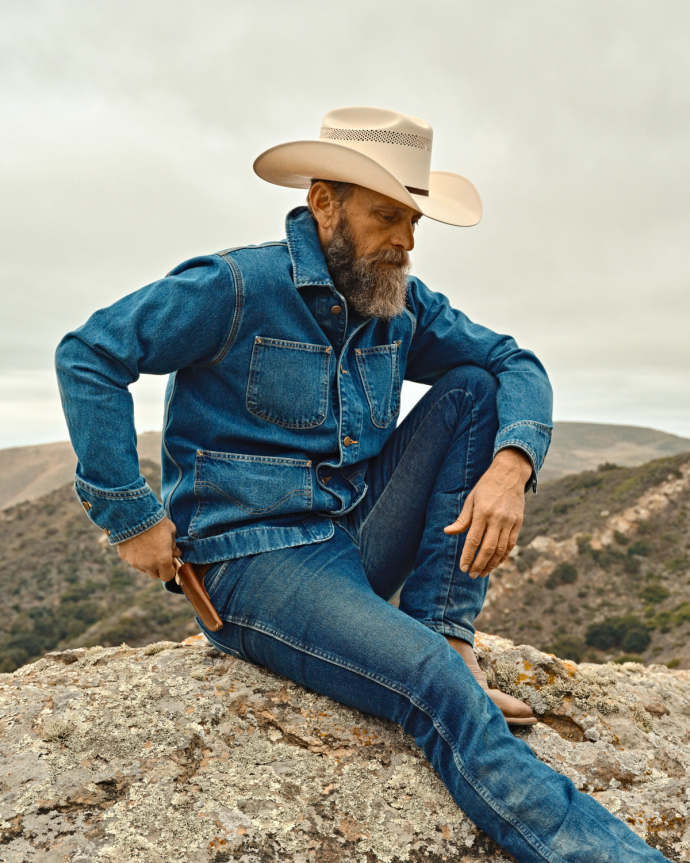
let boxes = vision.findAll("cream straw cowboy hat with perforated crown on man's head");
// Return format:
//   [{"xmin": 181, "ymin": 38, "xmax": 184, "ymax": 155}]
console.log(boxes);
[{"xmin": 254, "ymin": 108, "xmax": 482, "ymax": 227}]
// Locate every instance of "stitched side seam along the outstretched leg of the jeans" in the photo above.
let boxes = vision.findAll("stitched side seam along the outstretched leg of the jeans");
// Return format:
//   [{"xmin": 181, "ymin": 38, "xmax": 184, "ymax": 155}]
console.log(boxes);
[{"xmin": 216, "ymin": 617, "xmax": 566, "ymax": 863}]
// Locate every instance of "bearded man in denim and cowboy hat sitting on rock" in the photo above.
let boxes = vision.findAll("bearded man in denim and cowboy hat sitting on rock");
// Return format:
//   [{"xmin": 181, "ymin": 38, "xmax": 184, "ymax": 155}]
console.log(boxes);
[{"xmin": 57, "ymin": 108, "xmax": 663, "ymax": 863}]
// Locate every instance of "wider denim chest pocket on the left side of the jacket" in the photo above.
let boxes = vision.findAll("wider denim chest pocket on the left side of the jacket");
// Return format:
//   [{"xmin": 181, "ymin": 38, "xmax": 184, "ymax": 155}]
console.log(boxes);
[{"xmin": 246, "ymin": 336, "xmax": 333, "ymax": 429}]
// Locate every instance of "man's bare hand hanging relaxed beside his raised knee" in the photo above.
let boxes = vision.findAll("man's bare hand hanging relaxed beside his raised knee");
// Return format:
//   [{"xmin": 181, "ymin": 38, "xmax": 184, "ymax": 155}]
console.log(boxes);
[{"xmin": 444, "ymin": 448, "xmax": 532, "ymax": 578}]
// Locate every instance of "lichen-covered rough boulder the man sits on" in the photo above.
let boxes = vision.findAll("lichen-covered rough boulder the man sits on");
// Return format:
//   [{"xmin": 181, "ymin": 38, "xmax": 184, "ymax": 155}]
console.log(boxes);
[{"xmin": 0, "ymin": 635, "xmax": 690, "ymax": 863}]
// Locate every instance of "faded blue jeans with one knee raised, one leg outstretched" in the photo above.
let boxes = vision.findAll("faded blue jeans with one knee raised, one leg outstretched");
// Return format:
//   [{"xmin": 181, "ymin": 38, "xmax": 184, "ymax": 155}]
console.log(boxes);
[{"xmin": 196, "ymin": 366, "xmax": 665, "ymax": 863}]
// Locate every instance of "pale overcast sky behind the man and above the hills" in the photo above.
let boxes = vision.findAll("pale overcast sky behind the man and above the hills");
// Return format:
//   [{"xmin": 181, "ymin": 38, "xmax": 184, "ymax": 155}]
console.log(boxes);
[{"xmin": 0, "ymin": 0, "xmax": 690, "ymax": 447}]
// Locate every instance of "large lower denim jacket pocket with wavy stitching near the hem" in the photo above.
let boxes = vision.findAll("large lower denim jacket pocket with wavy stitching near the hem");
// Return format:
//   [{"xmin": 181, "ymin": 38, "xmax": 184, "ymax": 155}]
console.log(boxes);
[{"xmin": 189, "ymin": 450, "xmax": 312, "ymax": 538}]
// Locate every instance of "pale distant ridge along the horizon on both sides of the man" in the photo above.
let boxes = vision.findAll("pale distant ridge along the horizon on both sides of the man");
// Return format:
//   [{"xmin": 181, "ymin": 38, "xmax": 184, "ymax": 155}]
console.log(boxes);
[{"xmin": 0, "ymin": 422, "xmax": 690, "ymax": 509}]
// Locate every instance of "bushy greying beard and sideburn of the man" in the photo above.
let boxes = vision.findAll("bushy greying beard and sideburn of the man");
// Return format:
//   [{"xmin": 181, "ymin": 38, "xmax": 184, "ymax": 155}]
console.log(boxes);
[{"xmin": 323, "ymin": 213, "xmax": 410, "ymax": 320}]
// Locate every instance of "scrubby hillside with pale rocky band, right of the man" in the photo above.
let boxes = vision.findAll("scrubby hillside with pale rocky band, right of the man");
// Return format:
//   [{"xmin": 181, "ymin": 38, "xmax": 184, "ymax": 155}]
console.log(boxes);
[{"xmin": 477, "ymin": 454, "xmax": 690, "ymax": 668}]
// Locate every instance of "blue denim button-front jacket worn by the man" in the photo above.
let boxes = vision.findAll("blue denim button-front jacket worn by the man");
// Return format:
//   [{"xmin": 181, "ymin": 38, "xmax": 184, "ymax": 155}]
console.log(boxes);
[{"xmin": 56, "ymin": 207, "xmax": 551, "ymax": 563}]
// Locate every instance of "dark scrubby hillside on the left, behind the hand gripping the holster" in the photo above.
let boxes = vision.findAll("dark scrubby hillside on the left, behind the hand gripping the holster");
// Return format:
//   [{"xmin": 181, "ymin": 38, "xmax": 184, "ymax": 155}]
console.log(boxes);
[{"xmin": 0, "ymin": 461, "xmax": 198, "ymax": 672}]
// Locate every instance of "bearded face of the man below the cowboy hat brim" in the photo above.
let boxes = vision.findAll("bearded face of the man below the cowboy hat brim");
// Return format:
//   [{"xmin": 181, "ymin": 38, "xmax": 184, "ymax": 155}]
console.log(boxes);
[{"xmin": 323, "ymin": 186, "xmax": 421, "ymax": 319}]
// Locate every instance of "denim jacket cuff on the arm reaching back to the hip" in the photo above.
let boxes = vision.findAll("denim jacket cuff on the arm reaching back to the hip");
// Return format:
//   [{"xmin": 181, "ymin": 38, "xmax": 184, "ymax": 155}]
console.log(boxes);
[{"xmin": 74, "ymin": 476, "xmax": 165, "ymax": 545}]
